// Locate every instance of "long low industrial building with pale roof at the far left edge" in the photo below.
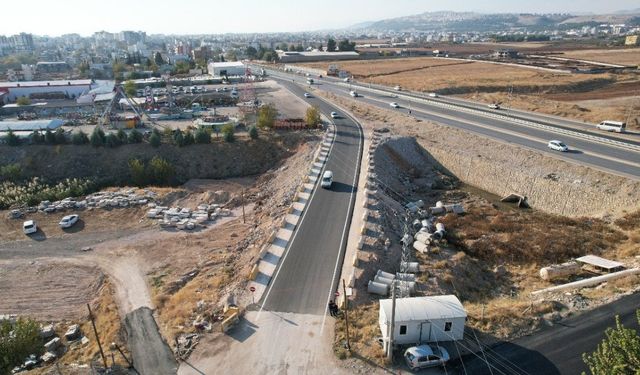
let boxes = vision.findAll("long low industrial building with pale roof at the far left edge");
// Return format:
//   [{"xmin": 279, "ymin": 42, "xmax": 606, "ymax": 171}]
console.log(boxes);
[{"xmin": 0, "ymin": 79, "xmax": 94, "ymax": 104}]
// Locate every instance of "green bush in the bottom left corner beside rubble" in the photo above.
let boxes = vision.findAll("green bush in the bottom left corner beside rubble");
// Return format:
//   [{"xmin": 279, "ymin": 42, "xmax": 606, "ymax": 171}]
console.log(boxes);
[{"xmin": 0, "ymin": 318, "xmax": 44, "ymax": 374}]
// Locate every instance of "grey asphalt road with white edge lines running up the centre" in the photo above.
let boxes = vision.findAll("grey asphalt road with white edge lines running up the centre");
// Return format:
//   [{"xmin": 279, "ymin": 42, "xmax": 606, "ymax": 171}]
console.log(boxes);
[{"xmin": 262, "ymin": 82, "xmax": 363, "ymax": 314}]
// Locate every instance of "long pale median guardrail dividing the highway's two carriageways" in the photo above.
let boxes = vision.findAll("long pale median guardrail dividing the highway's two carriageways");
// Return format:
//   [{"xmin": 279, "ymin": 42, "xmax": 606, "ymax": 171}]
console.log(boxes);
[{"xmin": 335, "ymin": 82, "xmax": 640, "ymax": 152}]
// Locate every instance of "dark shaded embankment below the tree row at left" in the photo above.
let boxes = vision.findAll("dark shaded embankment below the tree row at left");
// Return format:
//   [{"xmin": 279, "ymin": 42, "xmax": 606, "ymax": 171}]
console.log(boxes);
[{"xmin": 0, "ymin": 134, "xmax": 303, "ymax": 185}]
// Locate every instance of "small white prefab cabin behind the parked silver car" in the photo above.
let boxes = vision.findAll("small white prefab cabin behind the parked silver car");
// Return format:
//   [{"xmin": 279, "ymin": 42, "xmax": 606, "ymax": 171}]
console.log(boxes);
[{"xmin": 379, "ymin": 295, "xmax": 467, "ymax": 349}]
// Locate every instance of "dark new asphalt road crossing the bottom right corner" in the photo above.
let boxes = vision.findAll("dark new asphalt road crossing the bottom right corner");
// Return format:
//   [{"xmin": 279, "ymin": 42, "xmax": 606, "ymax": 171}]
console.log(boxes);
[{"xmin": 458, "ymin": 293, "xmax": 640, "ymax": 375}]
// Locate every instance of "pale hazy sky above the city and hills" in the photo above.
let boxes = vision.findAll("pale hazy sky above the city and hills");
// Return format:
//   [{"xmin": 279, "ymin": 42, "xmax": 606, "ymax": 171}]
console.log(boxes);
[{"xmin": 0, "ymin": 0, "xmax": 639, "ymax": 36}]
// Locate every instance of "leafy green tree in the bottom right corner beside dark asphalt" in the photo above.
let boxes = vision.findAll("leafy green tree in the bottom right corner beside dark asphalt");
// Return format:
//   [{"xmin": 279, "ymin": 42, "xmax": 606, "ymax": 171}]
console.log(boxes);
[{"xmin": 582, "ymin": 310, "xmax": 640, "ymax": 375}]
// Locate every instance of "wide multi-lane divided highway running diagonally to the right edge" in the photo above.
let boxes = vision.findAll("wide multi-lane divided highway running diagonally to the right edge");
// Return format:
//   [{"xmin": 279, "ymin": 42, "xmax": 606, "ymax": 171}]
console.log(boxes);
[{"xmin": 262, "ymin": 67, "xmax": 640, "ymax": 180}]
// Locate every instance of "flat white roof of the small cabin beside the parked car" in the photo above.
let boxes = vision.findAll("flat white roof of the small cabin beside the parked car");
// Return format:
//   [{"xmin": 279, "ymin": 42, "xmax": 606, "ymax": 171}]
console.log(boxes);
[{"xmin": 380, "ymin": 295, "xmax": 467, "ymax": 322}]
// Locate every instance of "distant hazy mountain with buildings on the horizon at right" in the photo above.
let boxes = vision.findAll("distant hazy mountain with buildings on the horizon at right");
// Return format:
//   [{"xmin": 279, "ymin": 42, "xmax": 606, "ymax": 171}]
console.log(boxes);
[{"xmin": 350, "ymin": 11, "xmax": 640, "ymax": 32}]
